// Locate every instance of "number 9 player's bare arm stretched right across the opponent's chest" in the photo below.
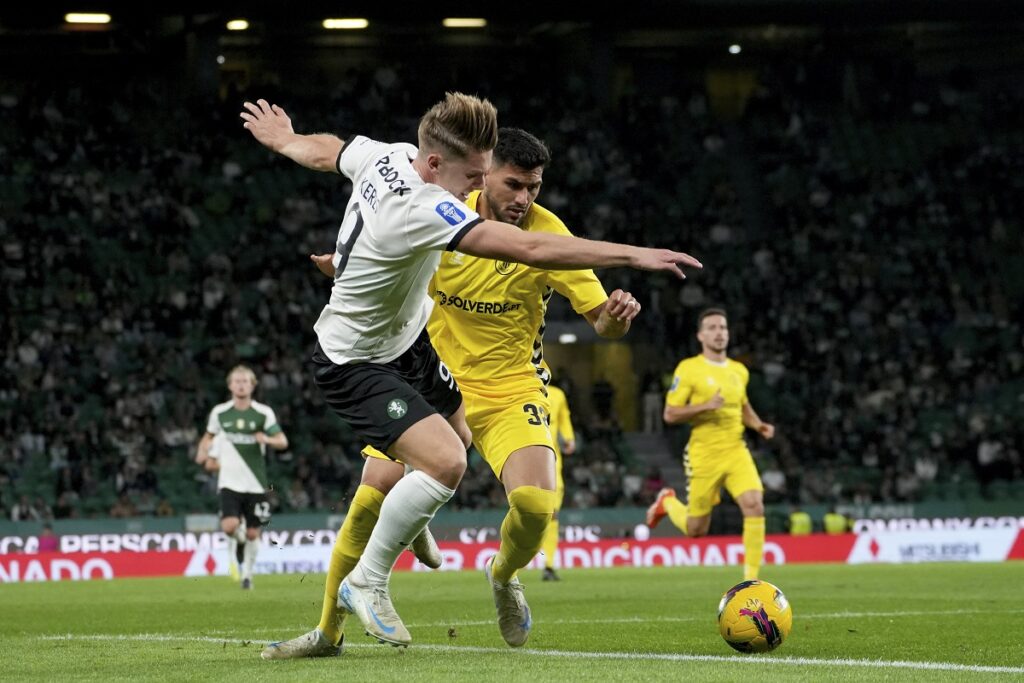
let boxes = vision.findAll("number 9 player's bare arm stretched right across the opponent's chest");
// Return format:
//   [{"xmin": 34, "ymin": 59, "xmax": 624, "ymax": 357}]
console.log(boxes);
[{"xmin": 459, "ymin": 220, "xmax": 703, "ymax": 279}]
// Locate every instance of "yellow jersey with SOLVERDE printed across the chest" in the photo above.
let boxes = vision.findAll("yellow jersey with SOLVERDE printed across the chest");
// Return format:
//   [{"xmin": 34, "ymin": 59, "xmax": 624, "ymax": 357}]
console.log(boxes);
[{"xmin": 427, "ymin": 193, "xmax": 608, "ymax": 395}]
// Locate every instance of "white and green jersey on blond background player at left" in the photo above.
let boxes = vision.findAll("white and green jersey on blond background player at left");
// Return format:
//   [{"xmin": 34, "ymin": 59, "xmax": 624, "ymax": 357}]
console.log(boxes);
[{"xmin": 206, "ymin": 400, "xmax": 281, "ymax": 494}]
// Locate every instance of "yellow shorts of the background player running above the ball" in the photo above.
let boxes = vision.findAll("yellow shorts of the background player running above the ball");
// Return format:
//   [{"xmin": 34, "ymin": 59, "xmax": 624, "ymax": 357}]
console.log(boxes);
[{"xmin": 683, "ymin": 445, "xmax": 764, "ymax": 517}]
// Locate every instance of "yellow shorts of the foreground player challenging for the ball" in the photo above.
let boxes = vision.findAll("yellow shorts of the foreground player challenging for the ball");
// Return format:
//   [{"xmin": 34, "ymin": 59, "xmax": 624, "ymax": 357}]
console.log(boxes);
[{"xmin": 362, "ymin": 387, "xmax": 560, "ymax": 479}]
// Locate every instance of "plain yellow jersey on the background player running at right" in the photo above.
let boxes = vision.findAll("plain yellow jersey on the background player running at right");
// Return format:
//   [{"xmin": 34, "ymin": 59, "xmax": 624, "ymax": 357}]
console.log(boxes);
[{"xmin": 666, "ymin": 354, "xmax": 751, "ymax": 457}]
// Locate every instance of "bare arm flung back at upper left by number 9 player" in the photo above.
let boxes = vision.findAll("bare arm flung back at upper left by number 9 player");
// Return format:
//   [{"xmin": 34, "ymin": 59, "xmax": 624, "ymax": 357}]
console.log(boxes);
[{"xmin": 239, "ymin": 99, "xmax": 344, "ymax": 172}]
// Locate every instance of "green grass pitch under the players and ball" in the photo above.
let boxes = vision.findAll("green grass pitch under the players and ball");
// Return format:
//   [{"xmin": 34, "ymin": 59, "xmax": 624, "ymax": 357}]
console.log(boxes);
[{"xmin": 0, "ymin": 562, "xmax": 1024, "ymax": 683}]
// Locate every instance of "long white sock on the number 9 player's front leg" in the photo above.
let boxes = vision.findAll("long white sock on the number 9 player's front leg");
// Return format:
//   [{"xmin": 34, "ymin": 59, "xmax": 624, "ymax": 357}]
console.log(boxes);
[{"xmin": 359, "ymin": 471, "xmax": 455, "ymax": 583}]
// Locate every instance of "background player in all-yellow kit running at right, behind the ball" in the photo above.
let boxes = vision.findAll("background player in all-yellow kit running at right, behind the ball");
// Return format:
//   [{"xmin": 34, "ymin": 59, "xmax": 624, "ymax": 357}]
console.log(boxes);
[{"xmin": 647, "ymin": 308, "xmax": 775, "ymax": 579}]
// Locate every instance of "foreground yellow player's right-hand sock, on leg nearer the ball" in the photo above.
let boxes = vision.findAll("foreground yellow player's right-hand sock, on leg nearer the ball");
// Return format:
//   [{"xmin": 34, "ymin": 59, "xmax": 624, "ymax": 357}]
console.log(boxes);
[{"xmin": 490, "ymin": 486, "xmax": 555, "ymax": 584}]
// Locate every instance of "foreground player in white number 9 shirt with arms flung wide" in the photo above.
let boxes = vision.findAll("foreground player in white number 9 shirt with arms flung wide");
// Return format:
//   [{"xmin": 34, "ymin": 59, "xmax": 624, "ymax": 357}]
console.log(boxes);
[{"xmin": 241, "ymin": 93, "xmax": 700, "ymax": 645}]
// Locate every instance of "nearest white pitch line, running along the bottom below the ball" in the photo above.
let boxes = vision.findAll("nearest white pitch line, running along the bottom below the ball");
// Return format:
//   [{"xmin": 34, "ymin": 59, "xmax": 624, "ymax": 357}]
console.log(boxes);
[{"xmin": 39, "ymin": 633, "xmax": 1024, "ymax": 674}]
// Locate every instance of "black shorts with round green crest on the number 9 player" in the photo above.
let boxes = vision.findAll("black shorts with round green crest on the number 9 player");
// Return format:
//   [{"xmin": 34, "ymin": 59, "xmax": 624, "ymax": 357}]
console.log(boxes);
[{"xmin": 313, "ymin": 330, "xmax": 462, "ymax": 454}]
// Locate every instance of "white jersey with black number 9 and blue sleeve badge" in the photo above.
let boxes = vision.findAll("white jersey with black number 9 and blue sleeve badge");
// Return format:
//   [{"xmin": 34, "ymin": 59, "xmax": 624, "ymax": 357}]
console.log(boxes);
[{"xmin": 313, "ymin": 135, "xmax": 482, "ymax": 365}]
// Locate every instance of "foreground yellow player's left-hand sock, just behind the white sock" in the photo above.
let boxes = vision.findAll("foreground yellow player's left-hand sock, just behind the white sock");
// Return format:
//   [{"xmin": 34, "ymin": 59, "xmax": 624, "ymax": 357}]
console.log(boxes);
[{"xmin": 317, "ymin": 485, "xmax": 384, "ymax": 644}]
